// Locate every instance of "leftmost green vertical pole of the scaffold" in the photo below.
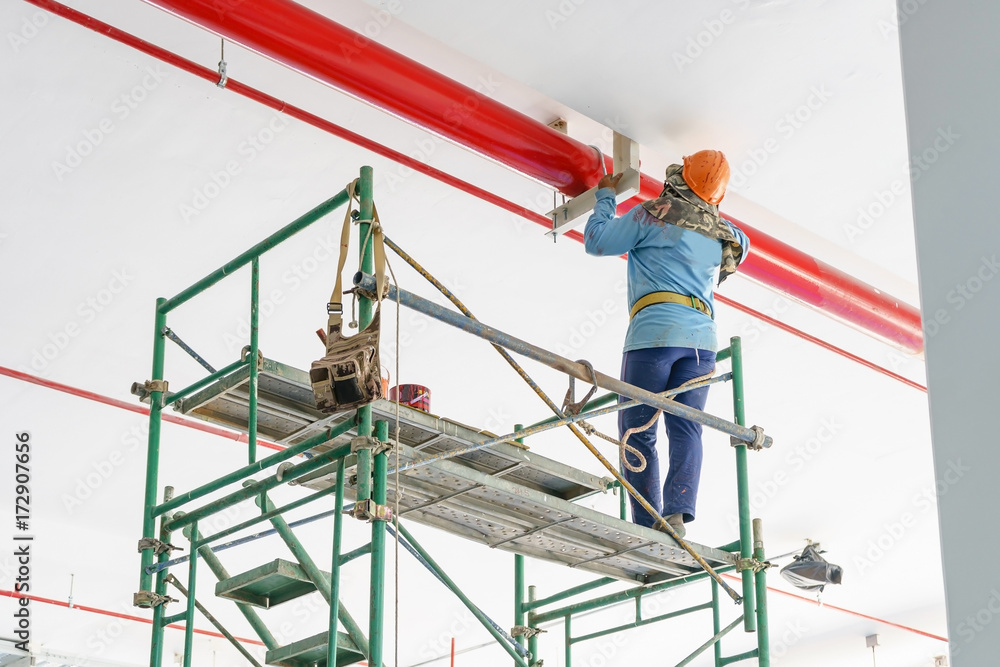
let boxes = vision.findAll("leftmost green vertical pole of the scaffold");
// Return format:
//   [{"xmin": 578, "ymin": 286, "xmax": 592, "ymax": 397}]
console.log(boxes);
[{"xmin": 139, "ymin": 298, "xmax": 167, "ymax": 667}]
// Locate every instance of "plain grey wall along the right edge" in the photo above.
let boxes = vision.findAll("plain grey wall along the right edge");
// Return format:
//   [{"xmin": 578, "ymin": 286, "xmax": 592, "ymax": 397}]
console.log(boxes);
[{"xmin": 898, "ymin": 0, "xmax": 1000, "ymax": 667}]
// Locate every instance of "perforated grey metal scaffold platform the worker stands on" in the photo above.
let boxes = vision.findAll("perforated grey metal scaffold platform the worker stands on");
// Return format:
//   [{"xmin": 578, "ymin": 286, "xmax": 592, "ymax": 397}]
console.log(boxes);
[{"xmin": 174, "ymin": 358, "xmax": 738, "ymax": 584}]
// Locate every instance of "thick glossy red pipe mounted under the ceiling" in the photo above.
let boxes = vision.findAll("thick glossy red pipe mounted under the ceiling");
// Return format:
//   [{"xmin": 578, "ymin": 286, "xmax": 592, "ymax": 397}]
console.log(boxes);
[{"xmin": 137, "ymin": 0, "xmax": 923, "ymax": 353}]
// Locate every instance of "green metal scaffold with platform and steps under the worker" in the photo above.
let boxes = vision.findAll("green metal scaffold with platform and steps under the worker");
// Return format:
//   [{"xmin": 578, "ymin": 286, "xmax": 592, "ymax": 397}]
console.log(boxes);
[{"xmin": 133, "ymin": 167, "xmax": 771, "ymax": 667}]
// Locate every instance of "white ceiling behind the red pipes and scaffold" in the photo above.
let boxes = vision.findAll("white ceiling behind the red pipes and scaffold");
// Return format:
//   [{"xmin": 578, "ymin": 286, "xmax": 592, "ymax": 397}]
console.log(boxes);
[{"xmin": 0, "ymin": 0, "xmax": 946, "ymax": 667}]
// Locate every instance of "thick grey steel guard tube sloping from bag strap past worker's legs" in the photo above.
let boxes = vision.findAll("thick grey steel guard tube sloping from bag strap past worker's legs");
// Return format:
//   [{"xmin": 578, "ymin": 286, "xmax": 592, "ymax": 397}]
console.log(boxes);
[{"xmin": 354, "ymin": 273, "xmax": 772, "ymax": 447}]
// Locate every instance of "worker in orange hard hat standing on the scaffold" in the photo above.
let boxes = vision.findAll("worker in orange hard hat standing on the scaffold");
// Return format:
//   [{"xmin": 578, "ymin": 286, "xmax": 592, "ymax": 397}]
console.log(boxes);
[{"xmin": 584, "ymin": 150, "xmax": 750, "ymax": 537}]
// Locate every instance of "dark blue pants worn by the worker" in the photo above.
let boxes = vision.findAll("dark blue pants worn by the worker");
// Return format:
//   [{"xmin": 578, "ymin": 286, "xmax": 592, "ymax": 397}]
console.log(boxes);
[{"xmin": 618, "ymin": 347, "xmax": 715, "ymax": 527}]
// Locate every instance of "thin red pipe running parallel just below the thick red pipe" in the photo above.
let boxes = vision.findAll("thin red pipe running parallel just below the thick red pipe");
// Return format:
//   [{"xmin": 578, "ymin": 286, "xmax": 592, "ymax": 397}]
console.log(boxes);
[{"xmin": 19, "ymin": 0, "xmax": 927, "ymax": 392}]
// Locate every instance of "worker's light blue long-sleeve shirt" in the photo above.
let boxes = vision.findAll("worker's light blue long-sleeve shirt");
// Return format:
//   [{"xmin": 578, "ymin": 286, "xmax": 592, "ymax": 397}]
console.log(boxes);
[{"xmin": 583, "ymin": 188, "xmax": 750, "ymax": 352}]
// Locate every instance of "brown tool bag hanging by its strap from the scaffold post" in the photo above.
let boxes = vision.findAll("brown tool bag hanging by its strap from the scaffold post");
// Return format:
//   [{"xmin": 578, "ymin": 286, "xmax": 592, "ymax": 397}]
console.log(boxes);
[{"xmin": 309, "ymin": 181, "xmax": 385, "ymax": 414}]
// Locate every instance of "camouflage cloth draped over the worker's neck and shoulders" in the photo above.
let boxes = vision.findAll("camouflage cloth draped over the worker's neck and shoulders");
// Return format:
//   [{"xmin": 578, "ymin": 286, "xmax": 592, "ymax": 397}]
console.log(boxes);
[{"xmin": 642, "ymin": 164, "xmax": 743, "ymax": 285}]
